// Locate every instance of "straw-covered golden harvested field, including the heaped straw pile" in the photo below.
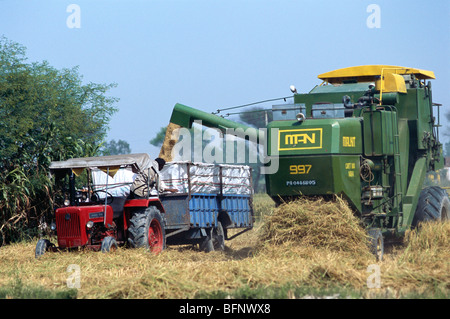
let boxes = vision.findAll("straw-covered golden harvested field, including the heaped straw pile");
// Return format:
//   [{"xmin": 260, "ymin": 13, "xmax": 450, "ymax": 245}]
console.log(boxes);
[{"xmin": 0, "ymin": 195, "xmax": 450, "ymax": 299}]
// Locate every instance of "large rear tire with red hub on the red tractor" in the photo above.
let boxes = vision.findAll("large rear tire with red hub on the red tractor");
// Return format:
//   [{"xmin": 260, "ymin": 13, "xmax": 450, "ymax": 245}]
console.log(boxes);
[{"xmin": 128, "ymin": 206, "xmax": 166, "ymax": 253}]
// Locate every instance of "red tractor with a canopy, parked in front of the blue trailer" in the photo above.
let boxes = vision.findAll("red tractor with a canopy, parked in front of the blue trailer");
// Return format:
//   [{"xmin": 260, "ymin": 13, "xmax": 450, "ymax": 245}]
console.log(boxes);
[{"xmin": 35, "ymin": 154, "xmax": 166, "ymax": 257}]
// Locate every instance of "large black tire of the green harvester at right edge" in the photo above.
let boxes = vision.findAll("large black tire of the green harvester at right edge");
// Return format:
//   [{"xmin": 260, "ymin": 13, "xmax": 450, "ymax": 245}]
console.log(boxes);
[{"xmin": 412, "ymin": 186, "xmax": 450, "ymax": 227}]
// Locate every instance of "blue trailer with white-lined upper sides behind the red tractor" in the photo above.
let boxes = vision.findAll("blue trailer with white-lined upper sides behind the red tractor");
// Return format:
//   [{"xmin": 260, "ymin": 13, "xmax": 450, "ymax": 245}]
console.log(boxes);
[{"xmin": 159, "ymin": 162, "xmax": 254, "ymax": 251}]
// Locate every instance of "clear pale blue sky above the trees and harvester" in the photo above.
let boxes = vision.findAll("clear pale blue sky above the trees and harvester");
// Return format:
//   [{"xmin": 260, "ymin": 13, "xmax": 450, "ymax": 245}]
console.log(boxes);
[{"xmin": 0, "ymin": 0, "xmax": 450, "ymax": 156}]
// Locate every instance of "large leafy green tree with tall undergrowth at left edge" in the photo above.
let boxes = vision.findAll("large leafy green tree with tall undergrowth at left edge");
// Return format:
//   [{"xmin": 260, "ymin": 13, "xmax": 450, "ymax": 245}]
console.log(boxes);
[{"xmin": 0, "ymin": 36, "xmax": 117, "ymax": 244}]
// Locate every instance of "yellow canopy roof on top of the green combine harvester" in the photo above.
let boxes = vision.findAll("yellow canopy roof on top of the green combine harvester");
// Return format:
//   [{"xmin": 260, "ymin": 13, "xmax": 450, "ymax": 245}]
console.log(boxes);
[{"xmin": 318, "ymin": 65, "xmax": 435, "ymax": 83}]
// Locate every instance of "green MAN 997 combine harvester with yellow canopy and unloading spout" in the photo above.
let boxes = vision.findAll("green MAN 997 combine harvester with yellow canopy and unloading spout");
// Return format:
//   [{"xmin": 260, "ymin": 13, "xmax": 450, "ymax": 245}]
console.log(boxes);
[{"xmin": 166, "ymin": 65, "xmax": 450, "ymax": 259}]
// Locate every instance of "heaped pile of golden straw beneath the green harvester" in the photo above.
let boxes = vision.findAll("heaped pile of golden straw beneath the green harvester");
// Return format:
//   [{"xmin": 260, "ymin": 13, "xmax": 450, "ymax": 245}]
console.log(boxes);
[{"xmin": 260, "ymin": 197, "xmax": 368, "ymax": 254}]
